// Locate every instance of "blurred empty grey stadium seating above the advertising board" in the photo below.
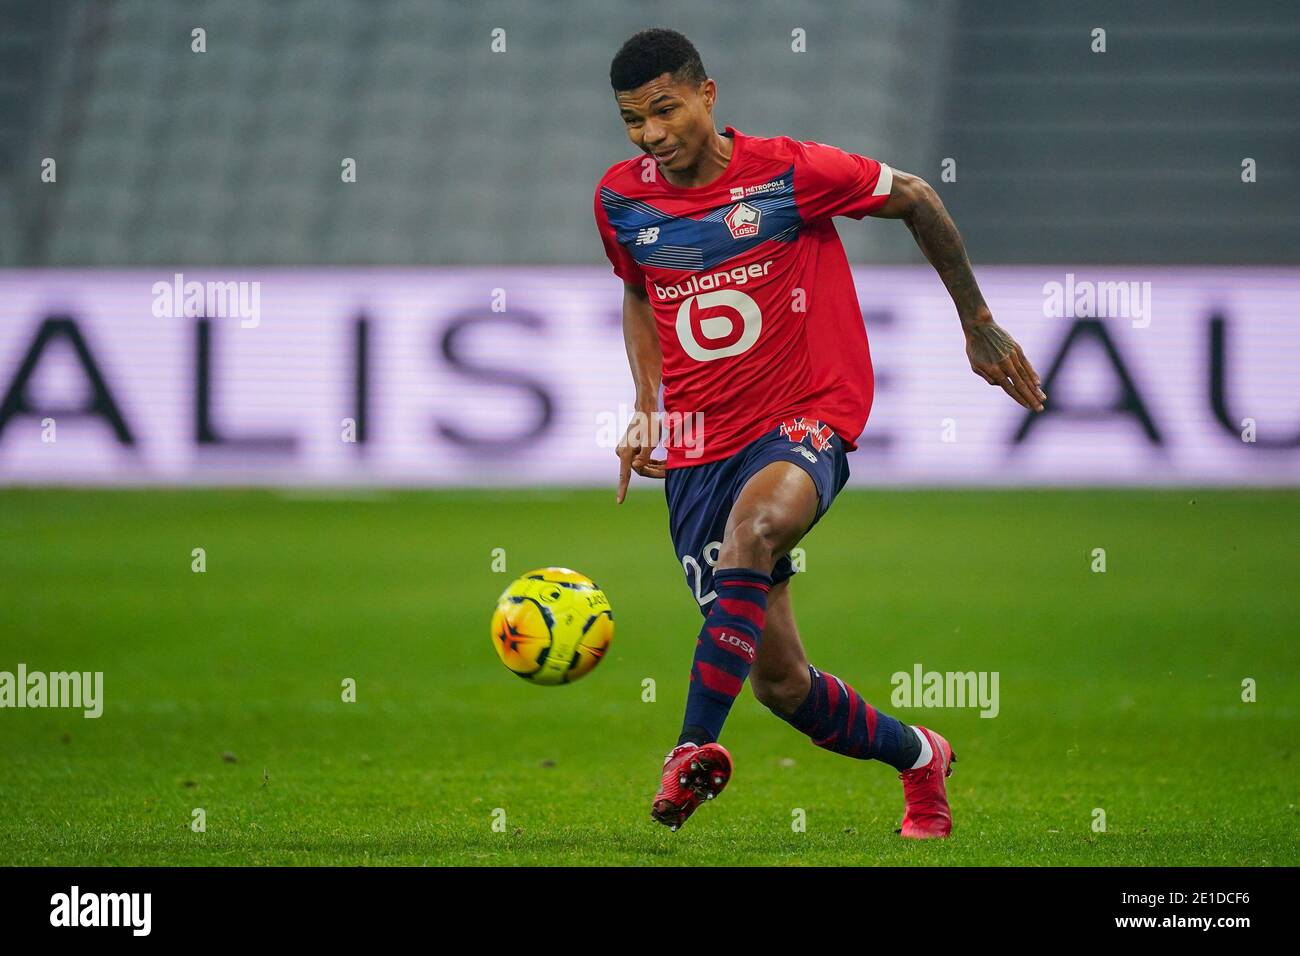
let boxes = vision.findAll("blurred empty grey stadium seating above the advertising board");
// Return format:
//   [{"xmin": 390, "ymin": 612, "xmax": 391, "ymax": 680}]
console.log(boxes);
[{"xmin": 0, "ymin": 0, "xmax": 1300, "ymax": 267}]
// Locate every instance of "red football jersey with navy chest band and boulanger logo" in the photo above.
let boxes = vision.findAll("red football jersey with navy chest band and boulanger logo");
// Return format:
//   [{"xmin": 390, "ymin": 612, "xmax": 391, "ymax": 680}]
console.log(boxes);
[{"xmin": 595, "ymin": 126, "xmax": 893, "ymax": 468}]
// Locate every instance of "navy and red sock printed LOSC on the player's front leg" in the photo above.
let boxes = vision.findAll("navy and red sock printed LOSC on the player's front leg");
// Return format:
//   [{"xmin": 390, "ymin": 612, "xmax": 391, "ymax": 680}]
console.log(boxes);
[{"xmin": 677, "ymin": 567, "xmax": 772, "ymax": 744}]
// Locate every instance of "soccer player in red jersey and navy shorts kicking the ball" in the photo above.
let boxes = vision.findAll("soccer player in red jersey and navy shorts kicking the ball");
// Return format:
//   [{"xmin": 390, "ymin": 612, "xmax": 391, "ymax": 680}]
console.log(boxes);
[{"xmin": 594, "ymin": 30, "xmax": 1047, "ymax": 838}]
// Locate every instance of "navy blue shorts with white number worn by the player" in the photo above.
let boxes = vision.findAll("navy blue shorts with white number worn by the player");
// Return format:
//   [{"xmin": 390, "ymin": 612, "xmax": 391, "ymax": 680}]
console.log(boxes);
[{"xmin": 664, "ymin": 419, "xmax": 849, "ymax": 614}]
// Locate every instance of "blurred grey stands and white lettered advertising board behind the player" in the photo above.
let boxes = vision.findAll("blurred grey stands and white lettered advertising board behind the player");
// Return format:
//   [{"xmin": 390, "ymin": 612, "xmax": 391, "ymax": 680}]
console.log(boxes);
[{"xmin": 0, "ymin": 0, "xmax": 1300, "ymax": 485}]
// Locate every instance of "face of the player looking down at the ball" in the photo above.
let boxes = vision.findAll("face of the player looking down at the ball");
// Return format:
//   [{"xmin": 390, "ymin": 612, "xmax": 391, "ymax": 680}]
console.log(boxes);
[{"xmin": 615, "ymin": 73, "xmax": 718, "ymax": 173}]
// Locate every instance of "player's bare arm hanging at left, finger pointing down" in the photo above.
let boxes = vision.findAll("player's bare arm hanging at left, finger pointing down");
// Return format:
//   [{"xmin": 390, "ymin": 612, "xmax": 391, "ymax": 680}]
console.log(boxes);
[{"xmin": 618, "ymin": 282, "xmax": 664, "ymax": 505}]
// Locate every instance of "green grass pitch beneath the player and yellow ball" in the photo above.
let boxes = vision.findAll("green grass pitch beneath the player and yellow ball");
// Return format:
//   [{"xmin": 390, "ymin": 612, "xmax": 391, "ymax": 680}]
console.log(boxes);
[{"xmin": 0, "ymin": 481, "xmax": 1300, "ymax": 865}]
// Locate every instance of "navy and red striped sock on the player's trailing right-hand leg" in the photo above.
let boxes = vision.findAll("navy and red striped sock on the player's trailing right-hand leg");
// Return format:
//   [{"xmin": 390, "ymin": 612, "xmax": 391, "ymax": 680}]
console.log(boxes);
[{"xmin": 772, "ymin": 666, "xmax": 922, "ymax": 770}]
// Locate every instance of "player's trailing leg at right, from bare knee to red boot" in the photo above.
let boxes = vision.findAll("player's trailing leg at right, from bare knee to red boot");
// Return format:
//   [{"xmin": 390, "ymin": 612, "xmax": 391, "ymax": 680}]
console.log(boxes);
[{"xmin": 749, "ymin": 567, "xmax": 957, "ymax": 839}]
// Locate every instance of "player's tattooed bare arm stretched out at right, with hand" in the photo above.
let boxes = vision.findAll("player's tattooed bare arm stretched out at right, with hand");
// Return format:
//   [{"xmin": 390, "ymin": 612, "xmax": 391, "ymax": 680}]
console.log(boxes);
[{"xmin": 871, "ymin": 169, "xmax": 1047, "ymax": 411}]
